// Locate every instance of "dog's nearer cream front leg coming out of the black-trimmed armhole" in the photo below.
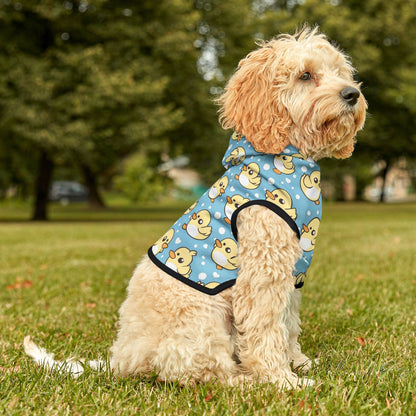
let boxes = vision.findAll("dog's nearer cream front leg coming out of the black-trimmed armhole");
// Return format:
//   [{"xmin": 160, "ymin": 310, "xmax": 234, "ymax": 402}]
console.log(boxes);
[{"xmin": 233, "ymin": 206, "xmax": 312, "ymax": 387}]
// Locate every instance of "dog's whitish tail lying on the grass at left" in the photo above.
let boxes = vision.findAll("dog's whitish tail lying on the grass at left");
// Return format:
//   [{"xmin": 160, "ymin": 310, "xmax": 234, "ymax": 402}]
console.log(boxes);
[{"xmin": 23, "ymin": 335, "xmax": 107, "ymax": 378}]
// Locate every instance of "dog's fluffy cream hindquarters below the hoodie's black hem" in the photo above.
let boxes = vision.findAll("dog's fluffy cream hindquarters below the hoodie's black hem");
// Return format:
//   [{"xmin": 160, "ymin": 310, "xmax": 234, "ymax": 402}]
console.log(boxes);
[{"xmin": 111, "ymin": 259, "xmax": 237, "ymax": 383}]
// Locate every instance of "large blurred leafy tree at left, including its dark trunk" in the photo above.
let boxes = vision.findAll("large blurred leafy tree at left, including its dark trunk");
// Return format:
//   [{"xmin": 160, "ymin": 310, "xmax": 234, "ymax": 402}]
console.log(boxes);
[{"xmin": 0, "ymin": 0, "xmax": 195, "ymax": 219}]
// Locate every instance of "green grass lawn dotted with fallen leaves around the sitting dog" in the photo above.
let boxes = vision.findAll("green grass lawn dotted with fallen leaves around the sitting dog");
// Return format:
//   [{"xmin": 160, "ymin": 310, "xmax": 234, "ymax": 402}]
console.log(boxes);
[{"xmin": 0, "ymin": 204, "xmax": 416, "ymax": 415}]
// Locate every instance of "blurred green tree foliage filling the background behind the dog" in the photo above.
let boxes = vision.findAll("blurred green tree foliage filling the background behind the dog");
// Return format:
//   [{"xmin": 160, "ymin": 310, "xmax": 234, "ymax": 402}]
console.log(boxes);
[{"xmin": 0, "ymin": 0, "xmax": 416, "ymax": 215}]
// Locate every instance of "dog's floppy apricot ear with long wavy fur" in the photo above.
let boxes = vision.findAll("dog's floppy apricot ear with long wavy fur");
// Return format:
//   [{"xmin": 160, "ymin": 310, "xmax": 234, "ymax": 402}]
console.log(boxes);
[{"xmin": 217, "ymin": 44, "xmax": 292, "ymax": 153}]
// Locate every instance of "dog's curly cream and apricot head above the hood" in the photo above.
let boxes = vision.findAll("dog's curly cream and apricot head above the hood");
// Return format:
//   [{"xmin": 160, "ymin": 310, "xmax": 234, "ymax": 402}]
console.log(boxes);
[{"xmin": 218, "ymin": 28, "xmax": 367, "ymax": 159}]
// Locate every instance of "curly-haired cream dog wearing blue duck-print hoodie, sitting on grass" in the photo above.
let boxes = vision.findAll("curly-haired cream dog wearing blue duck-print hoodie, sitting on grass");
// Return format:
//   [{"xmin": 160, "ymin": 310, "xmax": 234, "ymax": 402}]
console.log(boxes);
[{"xmin": 25, "ymin": 27, "xmax": 367, "ymax": 388}]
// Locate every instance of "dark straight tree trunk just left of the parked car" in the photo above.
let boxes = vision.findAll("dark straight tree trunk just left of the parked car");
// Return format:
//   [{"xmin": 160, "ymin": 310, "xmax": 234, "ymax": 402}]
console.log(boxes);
[{"xmin": 32, "ymin": 150, "xmax": 54, "ymax": 221}]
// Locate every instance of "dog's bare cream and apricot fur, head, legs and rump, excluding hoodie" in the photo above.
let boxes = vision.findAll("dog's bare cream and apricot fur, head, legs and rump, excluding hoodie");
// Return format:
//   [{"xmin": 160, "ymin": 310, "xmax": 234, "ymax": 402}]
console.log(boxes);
[{"xmin": 26, "ymin": 28, "xmax": 367, "ymax": 387}]
